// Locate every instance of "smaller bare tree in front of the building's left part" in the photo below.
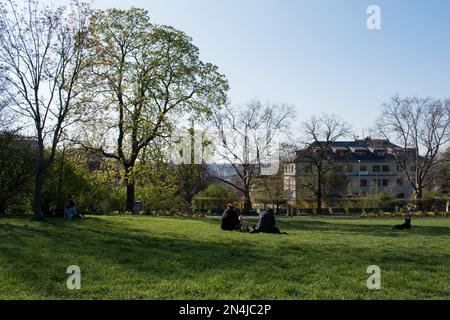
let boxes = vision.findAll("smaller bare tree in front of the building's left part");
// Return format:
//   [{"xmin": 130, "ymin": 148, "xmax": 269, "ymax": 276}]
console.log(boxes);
[{"xmin": 300, "ymin": 114, "xmax": 350, "ymax": 214}]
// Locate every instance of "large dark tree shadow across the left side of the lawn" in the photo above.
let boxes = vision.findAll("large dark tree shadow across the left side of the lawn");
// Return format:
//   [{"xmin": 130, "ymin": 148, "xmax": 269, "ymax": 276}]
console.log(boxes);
[{"xmin": 0, "ymin": 219, "xmax": 270, "ymax": 296}]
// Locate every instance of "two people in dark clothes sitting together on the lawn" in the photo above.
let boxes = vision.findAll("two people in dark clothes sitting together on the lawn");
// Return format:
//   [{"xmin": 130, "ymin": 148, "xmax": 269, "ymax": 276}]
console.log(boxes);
[{"xmin": 221, "ymin": 203, "xmax": 281, "ymax": 234}]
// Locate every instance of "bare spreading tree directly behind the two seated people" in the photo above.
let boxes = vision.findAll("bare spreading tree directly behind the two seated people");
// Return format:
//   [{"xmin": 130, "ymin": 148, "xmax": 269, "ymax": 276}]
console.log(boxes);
[{"xmin": 213, "ymin": 101, "xmax": 295, "ymax": 211}]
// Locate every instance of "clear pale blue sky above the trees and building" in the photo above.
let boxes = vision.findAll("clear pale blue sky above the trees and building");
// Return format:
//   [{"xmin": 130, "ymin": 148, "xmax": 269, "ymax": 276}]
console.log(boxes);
[{"xmin": 28, "ymin": 0, "xmax": 450, "ymax": 132}]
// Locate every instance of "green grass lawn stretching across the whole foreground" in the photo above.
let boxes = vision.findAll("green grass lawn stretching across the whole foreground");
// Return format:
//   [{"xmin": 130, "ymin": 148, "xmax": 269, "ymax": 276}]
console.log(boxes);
[{"xmin": 0, "ymin": 216, "xmax": 450, "ymax": 299}]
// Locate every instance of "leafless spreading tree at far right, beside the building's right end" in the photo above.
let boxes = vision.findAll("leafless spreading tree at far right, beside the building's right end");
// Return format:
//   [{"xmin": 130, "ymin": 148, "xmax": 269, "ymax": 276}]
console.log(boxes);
[{"xmin": 377, "ymin": 96, "xmax": 450, "ymax": 205}]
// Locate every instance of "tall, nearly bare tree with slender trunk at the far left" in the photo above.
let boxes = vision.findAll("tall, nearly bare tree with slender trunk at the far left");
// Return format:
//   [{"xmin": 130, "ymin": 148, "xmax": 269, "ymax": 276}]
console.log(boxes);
[{"xmin": 0, "ymin": 0, "xmax": 90, "ymax": 219}]
